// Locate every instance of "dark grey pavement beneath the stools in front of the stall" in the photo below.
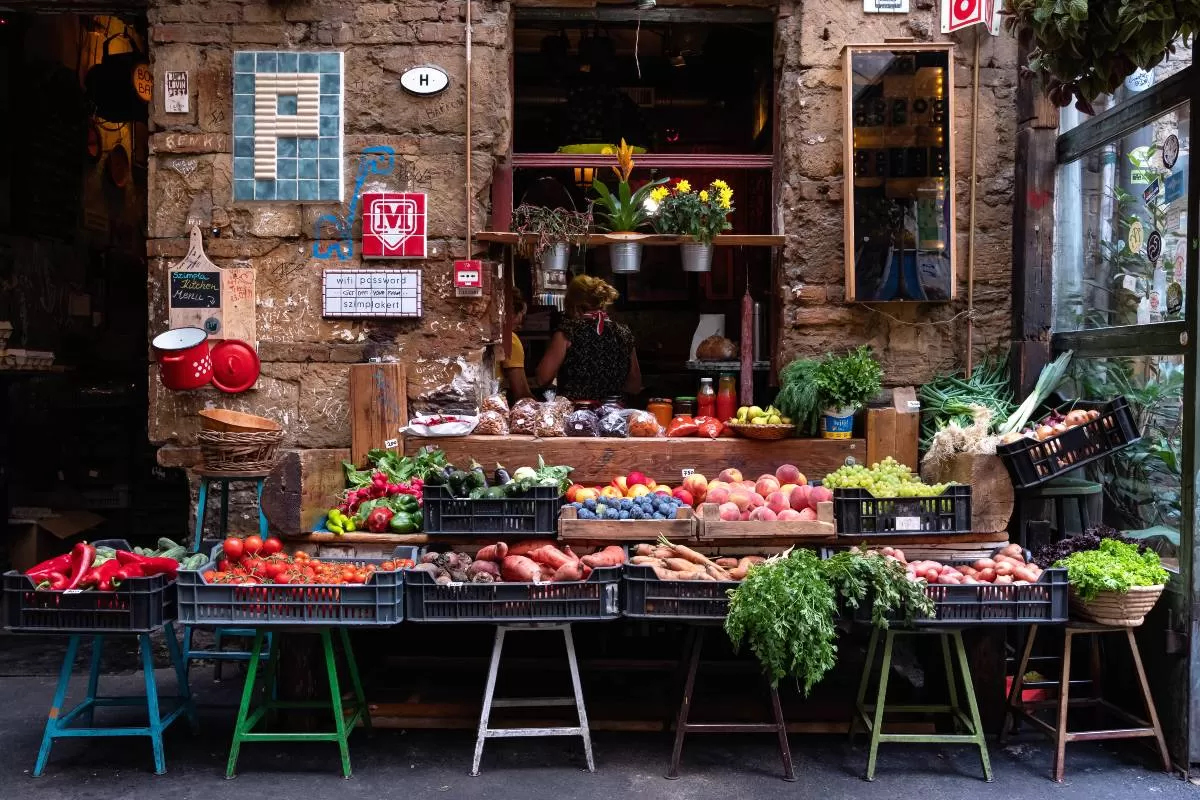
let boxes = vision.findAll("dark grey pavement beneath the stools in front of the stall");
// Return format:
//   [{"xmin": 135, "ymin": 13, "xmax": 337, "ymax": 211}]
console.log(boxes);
[{"xmin": 0, "ymin": 662, "xmax": 1198, "ymax": 800}]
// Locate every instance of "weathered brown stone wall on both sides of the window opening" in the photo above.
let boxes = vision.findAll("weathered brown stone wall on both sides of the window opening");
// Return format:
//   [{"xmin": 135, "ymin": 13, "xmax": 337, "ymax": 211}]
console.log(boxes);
[{"xmin": 148, "ymin": 0, "xmax": 1016, "ymax": 463}]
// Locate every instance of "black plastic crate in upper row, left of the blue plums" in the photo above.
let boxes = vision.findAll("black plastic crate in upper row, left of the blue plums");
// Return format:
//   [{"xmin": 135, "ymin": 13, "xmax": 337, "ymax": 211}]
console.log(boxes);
[{"xmin": 422, "ymin": 486, "xmax": 563, "ymax": 536}]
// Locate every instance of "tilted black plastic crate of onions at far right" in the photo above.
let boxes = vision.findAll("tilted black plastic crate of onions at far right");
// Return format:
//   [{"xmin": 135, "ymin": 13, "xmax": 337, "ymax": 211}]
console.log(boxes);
[{"xmin": 996, "ymin": 397, "xmax": 1141, "ymax": 489}]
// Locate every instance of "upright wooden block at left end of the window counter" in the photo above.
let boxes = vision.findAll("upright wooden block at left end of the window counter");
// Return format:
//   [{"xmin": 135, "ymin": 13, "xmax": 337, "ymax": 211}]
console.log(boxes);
[{"xmin": 350, "ymin": 363, "xmax": 408, "ymax": 468}]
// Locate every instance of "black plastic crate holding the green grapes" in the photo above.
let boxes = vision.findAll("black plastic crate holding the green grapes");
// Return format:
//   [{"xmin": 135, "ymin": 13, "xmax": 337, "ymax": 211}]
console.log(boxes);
[{"xmin": 833, "ymin": 485, "xmax": 971, "ymax": 539}]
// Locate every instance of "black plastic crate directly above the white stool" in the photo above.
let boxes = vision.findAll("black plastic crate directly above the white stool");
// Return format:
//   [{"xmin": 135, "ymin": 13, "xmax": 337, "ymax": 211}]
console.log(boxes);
[{"xmin": 404, "ymin": 566, "xmax": 622, "ymax": 622}]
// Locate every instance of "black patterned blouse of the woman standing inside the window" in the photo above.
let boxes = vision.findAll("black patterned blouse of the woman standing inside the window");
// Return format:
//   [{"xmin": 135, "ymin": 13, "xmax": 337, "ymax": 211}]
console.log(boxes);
[{"xmin": 558, "ymin": 318, "xmax": 634, "ymax": 402}]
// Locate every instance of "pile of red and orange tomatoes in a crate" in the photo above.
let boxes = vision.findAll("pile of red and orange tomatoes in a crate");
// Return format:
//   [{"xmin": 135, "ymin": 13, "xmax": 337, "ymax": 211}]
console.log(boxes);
[{"xmin": 204, "ymin": 536, "xmax": 413, "ymax": 585}]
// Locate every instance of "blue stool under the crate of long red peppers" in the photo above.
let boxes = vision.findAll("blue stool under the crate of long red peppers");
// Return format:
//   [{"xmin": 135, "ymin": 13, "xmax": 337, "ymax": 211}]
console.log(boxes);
[{"xmin": 34, "ymin": 622, "xmax": 199, "ymax": 777}]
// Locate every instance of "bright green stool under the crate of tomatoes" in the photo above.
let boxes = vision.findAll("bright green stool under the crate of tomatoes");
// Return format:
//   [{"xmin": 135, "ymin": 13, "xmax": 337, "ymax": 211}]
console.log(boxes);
[{"xmin": 226, "ymin": 627, "xmax": 371, "ymax": 778}]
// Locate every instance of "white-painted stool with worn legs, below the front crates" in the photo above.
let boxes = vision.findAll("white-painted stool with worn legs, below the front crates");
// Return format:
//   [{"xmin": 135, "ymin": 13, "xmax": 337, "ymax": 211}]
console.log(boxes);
[{"xmin": 470, "ymin": 622, "xmax": 596, "ymax": 775}]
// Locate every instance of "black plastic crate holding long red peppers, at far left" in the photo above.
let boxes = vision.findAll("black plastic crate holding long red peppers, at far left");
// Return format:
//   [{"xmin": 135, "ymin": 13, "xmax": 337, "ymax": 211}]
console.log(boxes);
[{"xmin": 4, "ymin": 539, "xmax": 176, "ymax": 633}]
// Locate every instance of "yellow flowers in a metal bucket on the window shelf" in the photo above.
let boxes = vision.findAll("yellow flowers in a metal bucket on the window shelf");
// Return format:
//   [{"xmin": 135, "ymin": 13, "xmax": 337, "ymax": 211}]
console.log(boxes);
[{"xmin": 650, "ymin": 180, "xmax": 733, "ymax": 272}]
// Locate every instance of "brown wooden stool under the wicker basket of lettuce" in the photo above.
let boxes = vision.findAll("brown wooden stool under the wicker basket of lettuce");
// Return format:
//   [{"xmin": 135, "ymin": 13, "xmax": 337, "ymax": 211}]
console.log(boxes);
[{"xmin": 1001, "ymin": 621, "xmax": 1171, "ymax": 783}]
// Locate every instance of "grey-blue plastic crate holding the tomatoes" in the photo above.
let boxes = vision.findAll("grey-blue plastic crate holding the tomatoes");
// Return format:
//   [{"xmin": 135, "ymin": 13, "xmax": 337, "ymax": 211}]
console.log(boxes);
[{"xmin": 179, "ymin": 546, "xmax": 418, "ymax": 627}]
